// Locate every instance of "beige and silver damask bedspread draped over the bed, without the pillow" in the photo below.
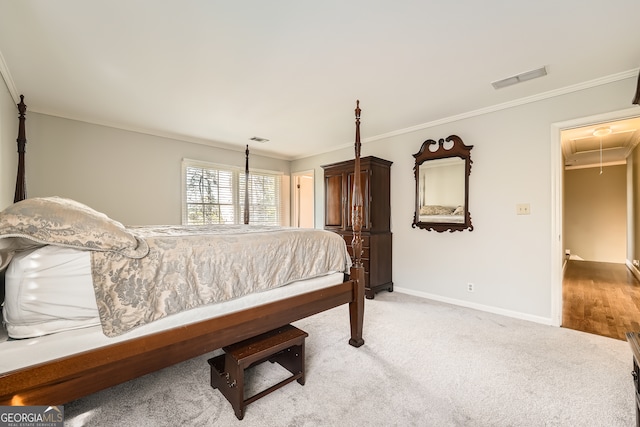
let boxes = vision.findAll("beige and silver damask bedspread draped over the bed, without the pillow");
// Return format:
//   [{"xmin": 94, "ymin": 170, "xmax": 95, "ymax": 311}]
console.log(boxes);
[{"xmin": 91, "ymin": 225, "xmax": 351, "ymax": 336}]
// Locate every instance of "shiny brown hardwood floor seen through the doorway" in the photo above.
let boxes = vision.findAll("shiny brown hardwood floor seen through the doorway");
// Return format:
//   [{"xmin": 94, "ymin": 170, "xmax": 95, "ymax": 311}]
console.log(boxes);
[{"xmin": 562, "ymin": 260, "xmax": 640, "ymax": 340}]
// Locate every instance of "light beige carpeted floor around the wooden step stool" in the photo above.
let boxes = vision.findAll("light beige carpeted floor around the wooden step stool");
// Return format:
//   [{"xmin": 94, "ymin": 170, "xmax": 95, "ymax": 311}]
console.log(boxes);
[{"xmin": 65, "ymin": 292, "xmax": 635, "ymax": 427}]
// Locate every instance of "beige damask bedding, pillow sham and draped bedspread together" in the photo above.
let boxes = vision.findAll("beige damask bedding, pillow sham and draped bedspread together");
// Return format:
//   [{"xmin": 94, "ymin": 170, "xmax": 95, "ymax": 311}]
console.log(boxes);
[{"xmin": 0, "ymin": 197, "xmax": 351, "ymax": 337}]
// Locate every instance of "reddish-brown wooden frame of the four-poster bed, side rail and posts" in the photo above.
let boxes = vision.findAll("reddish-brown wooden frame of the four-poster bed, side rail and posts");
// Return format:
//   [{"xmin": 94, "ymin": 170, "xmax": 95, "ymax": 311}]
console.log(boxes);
[{"xmin": 0, "ymin": 97, "xmax": 364, "ymax": 405}]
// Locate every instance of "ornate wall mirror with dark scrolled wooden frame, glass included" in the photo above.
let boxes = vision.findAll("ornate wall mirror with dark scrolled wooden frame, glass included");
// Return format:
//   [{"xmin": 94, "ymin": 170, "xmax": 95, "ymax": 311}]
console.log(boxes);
[{"xmin": 412, "ymin": 135, "xmax": 473, "ymax": 232}]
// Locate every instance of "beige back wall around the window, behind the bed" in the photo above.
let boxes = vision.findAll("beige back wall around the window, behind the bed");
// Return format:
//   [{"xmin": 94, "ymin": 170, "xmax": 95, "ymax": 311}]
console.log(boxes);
[{"xmin": 25, "ymin": 112, "xmax": 290, "ymax": 225}]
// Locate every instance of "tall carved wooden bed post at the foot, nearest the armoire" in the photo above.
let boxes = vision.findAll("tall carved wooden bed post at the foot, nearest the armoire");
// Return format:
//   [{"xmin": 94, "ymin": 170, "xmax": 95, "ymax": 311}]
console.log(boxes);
[{"xmin": 349, "ymin": 100, "xmax": 364, "ymax": 347}]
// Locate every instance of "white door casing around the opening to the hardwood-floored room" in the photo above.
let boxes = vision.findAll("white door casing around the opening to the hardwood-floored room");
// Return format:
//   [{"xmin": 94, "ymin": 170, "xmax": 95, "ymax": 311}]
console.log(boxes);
[{"xmin": 551, "ymin": 108, "xmax": 638, "ymax": 326}]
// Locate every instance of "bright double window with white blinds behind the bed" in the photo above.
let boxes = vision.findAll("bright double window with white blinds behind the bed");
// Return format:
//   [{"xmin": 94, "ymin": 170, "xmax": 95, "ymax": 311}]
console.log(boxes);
[{"xmin": 182, "ymin": 159, "xmax": 283, "ymax": 225}]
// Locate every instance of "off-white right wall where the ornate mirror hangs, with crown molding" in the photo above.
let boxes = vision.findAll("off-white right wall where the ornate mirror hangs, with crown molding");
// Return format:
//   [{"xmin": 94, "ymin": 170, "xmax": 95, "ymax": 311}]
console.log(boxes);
[{"xmin": 292, "ymin": 79, "xmax": 640, "ymax": 324}]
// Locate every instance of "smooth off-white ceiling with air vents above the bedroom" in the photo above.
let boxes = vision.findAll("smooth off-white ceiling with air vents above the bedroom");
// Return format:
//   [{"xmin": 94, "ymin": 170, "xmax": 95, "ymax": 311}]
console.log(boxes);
[{"xmin": 0, "ymin": 0, "xmax": 640, "ymax": 159}]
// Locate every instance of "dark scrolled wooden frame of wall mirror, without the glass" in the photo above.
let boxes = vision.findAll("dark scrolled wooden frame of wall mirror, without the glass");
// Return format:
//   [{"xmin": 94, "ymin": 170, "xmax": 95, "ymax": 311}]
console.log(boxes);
[{"xmin": 411, "ymin": 135, "xmax": 473, "ymax": 233}]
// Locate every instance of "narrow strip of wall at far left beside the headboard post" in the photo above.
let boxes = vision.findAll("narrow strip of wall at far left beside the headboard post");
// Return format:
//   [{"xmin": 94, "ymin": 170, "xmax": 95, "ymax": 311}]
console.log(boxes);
[{"xmin": 0, "ymin": 77, "xmax": 17, "ymax": 210}]
